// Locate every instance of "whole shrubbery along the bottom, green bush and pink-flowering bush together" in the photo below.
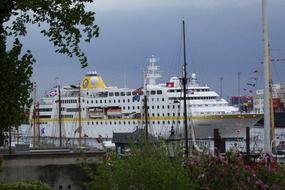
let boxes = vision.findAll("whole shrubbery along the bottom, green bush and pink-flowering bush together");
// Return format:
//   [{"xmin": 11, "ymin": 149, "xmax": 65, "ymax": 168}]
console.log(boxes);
[{"xmin": 81, "ymin": 145, "xmax": 285, "ymax": 190}]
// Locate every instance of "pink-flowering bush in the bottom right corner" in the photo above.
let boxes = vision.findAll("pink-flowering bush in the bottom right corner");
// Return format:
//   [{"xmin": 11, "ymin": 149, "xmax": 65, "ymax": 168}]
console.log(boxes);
[{"xmin": 186, "ymin": 152, "xmax": 285, "ymax": 190}]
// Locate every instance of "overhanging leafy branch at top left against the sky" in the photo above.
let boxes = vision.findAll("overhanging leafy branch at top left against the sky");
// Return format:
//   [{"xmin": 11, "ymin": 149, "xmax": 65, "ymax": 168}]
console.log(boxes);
[{"xmin": 0, "ymin": 0, "xmax": 99, "ymax": 67}]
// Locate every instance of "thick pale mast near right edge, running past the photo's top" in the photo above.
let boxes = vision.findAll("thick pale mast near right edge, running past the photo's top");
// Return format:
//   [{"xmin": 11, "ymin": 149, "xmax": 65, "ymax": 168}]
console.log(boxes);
[{"xmin": 262, "ymin": 0, "xmax": 271, "ymax": 154}]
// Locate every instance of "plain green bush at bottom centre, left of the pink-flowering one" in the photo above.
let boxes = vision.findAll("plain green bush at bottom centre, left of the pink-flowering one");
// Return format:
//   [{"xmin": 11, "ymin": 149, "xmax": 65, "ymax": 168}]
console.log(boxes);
[{"xmin": 85, "ymin": 146, "xmax": 191, "ymax": 190}]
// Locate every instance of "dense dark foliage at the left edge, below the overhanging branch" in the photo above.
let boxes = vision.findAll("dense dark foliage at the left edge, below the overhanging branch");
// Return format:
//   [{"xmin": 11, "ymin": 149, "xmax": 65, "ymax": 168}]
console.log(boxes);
[{"xmin": 0, "ymin": 39, "xmax": 34, "ymax": 145}]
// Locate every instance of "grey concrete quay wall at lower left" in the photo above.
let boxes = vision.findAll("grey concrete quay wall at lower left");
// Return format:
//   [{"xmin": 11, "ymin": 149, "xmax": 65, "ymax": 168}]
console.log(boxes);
[{"xmin": 0, "ymin": 151, "xmax": 105, "ymax": 190}]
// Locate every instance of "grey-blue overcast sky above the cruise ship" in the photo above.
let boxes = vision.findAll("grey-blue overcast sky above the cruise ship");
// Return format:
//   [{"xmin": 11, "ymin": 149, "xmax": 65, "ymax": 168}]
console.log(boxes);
[{"xmin": 21, "ymin": 0, "xmax": 285, "ymax": 98}]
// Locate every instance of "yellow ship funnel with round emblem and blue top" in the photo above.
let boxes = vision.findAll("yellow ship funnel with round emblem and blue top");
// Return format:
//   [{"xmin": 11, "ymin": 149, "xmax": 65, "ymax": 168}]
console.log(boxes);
[{"xmin": 81, "ymin": 71, "xmax": 106, "ymax": 89}]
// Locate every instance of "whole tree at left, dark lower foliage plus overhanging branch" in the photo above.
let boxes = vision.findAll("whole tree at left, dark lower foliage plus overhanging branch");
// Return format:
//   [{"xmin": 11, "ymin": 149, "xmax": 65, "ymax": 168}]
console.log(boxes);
[{"xmin": 0, "ymin": 0, "xmax": 99, "ymax": 146}]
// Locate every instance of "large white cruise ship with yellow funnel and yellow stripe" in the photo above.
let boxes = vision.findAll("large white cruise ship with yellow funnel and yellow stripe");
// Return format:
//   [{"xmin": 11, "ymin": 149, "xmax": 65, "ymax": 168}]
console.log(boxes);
[{"xmin": 30, "ymin": 56, "xmax": 262, "ymax": 142}]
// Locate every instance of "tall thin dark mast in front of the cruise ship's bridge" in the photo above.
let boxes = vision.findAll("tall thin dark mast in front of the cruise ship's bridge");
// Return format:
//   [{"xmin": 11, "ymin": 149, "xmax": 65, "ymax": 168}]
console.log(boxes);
[{"xmin": 182, "ymin": 20, "xmax": 189, "ymax": 158}]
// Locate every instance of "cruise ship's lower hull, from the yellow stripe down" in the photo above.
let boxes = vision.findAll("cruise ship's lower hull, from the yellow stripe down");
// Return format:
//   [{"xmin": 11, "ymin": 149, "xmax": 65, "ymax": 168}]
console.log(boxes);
[{"xmin": 36, "ymin": 114, "xmax": 261, "ymax": 139}]
